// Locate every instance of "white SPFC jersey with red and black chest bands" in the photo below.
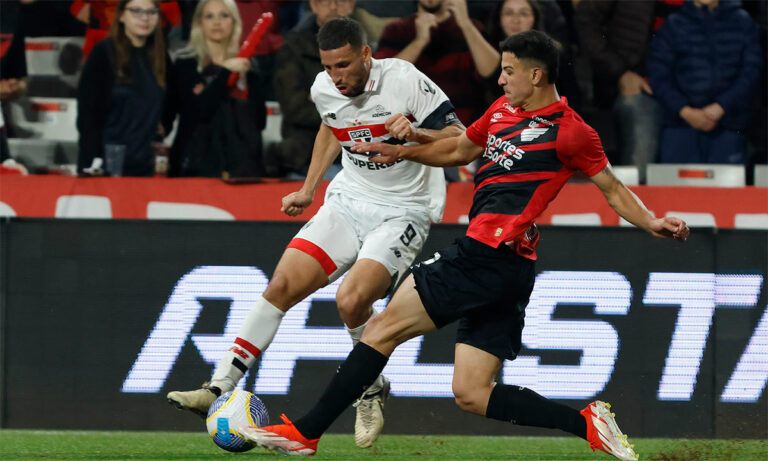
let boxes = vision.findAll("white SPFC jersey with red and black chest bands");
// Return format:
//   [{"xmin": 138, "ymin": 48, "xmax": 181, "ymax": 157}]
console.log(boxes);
[{"xmin": 312, "ymin": 59, "xmax": 460, "ymax": 222}]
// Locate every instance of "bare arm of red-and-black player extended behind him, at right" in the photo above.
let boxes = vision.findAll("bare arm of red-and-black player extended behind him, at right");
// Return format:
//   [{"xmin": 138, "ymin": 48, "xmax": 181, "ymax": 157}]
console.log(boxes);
[{"xmin": 590, "ymin": 165, "xmax": 691, "ymax": 242}]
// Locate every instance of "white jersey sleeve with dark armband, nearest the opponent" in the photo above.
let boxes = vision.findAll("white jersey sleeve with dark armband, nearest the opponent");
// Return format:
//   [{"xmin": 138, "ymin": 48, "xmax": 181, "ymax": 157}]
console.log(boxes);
[{"xmin": 400, "ymin": 66, "xmax": 461, "ymax": 130}]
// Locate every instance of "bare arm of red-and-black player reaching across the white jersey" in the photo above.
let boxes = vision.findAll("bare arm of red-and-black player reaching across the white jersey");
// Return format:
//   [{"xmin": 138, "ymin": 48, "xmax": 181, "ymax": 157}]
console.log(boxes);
[{"xmin": 351, "ymin": 133, "xmax": 483, "ymax": 166}]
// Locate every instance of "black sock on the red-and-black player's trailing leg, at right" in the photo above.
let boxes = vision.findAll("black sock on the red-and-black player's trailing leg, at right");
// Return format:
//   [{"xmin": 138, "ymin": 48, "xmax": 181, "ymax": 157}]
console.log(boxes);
[{"xmin": 485, "ymin": 384, "xmax": 587, "ymax": 440}]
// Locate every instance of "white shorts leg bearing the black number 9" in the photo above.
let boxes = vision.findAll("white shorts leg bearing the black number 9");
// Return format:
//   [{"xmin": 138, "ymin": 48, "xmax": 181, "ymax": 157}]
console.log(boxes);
[{"xmin": 357, "ymin": 207, "xmax": 430, "ymax": 290}]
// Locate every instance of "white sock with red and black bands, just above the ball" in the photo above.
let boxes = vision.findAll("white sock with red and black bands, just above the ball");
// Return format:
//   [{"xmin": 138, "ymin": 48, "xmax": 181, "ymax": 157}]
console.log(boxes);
[{"xmin": 211, "ymin": 296, "xmax": 285, "ymax": 394}]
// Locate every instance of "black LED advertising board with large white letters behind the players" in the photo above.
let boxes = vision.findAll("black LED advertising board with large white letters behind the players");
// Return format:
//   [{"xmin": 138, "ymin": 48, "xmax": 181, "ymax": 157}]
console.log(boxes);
[{"xmin": 0, "ymin": 218, "xmax": 768, "ymax": 438}]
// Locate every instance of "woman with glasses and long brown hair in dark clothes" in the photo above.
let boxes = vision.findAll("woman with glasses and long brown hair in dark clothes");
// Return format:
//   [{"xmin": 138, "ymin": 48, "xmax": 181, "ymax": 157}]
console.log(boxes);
[{"xmin": 77, "ymin": 0, "xmax": 170, "ymax": 176}]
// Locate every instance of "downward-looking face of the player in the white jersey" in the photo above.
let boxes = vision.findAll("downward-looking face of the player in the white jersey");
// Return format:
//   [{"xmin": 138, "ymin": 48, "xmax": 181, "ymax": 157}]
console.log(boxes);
[{"xmin": 320, "ymin": 43, "xmax": 371, "ymax": 98}]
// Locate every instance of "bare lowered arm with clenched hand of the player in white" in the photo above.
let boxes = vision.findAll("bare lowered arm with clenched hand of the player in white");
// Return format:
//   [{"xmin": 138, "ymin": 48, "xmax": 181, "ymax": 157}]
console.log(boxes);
[{"xmin": 280, "ymin": 123, "xmax": 341, "ymax": 216}]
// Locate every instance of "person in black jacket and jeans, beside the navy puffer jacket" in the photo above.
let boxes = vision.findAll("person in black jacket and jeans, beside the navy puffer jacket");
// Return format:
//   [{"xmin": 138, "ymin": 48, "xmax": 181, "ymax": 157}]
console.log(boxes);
[{"xmin": 574, "ymin": 0, "xmax": 661, "ymax": 181}]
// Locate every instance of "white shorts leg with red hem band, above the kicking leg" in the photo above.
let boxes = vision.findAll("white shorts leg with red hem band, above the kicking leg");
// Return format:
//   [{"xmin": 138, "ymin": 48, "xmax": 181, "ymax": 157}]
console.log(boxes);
[{"xmin": 288, "ymin": 199, "xmax": 360, "ymax": 282}]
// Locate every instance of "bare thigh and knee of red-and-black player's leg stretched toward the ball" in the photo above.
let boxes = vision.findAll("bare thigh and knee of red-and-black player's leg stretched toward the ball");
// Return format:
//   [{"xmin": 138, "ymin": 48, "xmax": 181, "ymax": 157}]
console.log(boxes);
[{"xmin": 362, "ymin": 275, "xmax": 436, "ymax": 355}]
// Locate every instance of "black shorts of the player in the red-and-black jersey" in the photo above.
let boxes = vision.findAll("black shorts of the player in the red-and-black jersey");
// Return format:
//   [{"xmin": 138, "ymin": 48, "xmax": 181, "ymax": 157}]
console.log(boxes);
[{"xmin": 413, "ymin": 236, "xmax": 536, "ymax": 360}]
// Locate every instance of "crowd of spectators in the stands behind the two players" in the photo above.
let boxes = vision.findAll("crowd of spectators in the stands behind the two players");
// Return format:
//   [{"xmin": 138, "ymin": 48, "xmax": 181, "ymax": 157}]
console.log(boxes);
[{"xmin": 0, "ymin": 0, "xmax": 768, "ymax": 181}]
